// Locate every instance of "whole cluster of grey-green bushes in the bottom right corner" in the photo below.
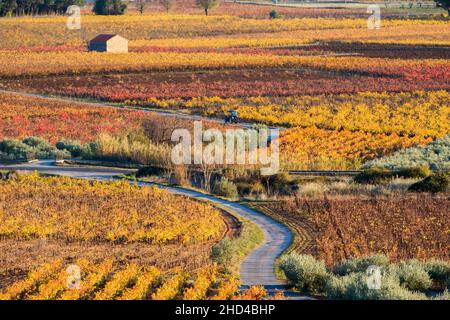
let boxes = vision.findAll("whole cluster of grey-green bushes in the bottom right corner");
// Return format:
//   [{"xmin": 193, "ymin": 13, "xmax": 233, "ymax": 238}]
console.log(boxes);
[{"xmin": 279, "ymin": 253, "xmax": 450, "ymax": 300}]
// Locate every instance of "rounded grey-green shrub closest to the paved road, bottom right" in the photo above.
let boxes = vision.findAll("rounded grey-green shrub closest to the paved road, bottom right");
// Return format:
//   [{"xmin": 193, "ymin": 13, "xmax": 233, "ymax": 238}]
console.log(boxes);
[{"xmin": 280, "ymin": 253, "xmax": 330, "ymax": 293}]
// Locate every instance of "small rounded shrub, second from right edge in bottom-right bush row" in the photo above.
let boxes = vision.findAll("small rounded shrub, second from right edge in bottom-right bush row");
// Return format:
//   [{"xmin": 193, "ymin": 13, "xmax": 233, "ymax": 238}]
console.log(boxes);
[{"xmin": 397, "ymin": 260, "xmax": 432, "ymax": 292}]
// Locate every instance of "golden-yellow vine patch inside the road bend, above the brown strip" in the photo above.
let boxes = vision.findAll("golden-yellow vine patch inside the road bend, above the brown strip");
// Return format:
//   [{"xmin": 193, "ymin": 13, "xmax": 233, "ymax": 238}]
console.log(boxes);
[{"xmin": 0, "ymin": 175, "xmax": 225, "ymax": 244}]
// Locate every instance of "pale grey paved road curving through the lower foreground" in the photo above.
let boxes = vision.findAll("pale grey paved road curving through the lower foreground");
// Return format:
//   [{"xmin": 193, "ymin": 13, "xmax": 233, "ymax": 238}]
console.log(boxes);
[{"xmin": 0, "ymin": 160, "xmax": 293, "ymax": 290}]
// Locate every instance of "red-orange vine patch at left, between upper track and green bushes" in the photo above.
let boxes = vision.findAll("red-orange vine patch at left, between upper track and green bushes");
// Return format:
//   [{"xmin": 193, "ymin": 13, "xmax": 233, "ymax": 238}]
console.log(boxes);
[{"xmin": 0, "ymin": 93, "xmax": 149, "ymax": 143}]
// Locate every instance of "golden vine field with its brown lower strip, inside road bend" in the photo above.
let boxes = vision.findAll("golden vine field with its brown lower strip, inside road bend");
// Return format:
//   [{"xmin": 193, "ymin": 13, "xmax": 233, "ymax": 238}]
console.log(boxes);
[{"xmin": 0, "ymin": 175, "xmax": 228, "ymax": 287}]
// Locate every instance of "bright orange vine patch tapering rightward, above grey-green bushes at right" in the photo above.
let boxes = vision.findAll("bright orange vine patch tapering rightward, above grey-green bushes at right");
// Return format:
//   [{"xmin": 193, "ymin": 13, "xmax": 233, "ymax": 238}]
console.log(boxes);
[{"xmin": 280, "ymin": 126, "xmax": 432, "ymax": 170}]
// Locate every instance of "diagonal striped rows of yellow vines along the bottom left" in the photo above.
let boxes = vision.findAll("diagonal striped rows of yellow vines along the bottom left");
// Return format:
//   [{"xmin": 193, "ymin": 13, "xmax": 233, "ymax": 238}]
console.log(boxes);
[{"xmin": 0, "ymin": 259, "xmax": 238, "ymax": 300}]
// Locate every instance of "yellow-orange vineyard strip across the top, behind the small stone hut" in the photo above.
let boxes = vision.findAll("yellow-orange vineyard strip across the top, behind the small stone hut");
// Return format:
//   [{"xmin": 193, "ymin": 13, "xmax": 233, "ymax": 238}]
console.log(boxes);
[{"xmin": 0, "ymin": 10, "xmax": 448, "ymax": 48}]
